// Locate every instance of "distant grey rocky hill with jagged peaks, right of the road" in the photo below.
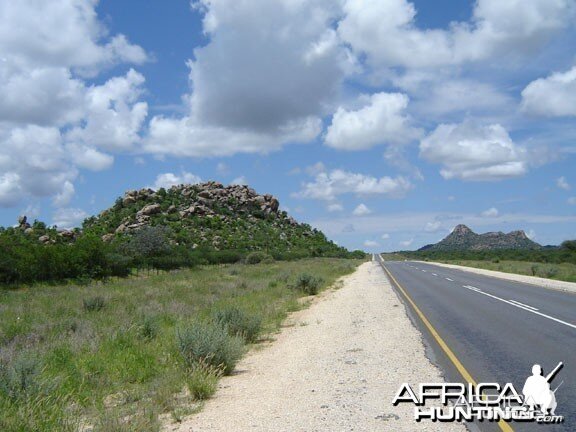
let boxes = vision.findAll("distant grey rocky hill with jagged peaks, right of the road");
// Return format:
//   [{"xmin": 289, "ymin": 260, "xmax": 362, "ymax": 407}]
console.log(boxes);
[{"xmin": 419, "ymin": 225, "xmax": 541, "ymax": 251}]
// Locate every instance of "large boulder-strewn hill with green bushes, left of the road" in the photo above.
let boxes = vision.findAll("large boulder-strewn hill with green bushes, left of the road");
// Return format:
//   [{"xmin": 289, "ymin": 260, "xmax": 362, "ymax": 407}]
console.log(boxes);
[{"xmin": 83, "ymin": 182, "xmax": 347, "ymax": 256}]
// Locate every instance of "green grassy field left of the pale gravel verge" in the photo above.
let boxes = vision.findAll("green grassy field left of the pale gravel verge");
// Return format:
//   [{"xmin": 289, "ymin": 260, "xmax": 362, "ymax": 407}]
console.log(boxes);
[{"xmin": 0, "ymin": 258, "xmax": 360, "ymax": 432}]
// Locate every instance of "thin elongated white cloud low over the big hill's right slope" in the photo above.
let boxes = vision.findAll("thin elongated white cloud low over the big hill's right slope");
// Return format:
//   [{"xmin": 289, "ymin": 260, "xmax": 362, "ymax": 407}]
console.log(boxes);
[{"xmin": 294, "ymin": 170, "xmax": 412, "ymax": 201}]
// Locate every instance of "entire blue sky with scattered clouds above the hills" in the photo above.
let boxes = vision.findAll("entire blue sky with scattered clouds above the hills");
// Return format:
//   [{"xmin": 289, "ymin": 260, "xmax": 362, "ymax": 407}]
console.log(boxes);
[{"xmin": 0, "ymin": 0, "xmax": 576, "ymax": 251}]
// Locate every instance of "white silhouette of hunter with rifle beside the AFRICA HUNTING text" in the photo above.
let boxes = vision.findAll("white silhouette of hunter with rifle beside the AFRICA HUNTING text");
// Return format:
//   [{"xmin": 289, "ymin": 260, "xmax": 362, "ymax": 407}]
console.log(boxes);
[{"xmin": 522, "ymin": 362, "xmax": 564, "ymax": 415}]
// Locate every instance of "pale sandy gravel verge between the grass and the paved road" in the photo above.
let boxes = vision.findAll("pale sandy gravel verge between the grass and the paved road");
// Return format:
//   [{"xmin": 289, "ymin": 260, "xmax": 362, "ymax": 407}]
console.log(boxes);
[{"xmin": 165, "ymin": 262, "xmax": 466, "ymax": 432}]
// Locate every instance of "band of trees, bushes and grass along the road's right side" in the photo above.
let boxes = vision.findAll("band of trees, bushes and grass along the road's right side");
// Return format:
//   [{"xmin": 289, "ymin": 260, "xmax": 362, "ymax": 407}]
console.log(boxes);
[{"xmin": 392, "ymin": 240, "xmax": 576, "ymax": 282}]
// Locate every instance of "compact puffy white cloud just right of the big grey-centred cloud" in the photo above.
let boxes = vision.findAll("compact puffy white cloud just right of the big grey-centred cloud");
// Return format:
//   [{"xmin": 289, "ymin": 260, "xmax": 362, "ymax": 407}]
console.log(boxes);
[{"xmin": 324, "ymin": 93, "xmax": 421, "ymax": 150}]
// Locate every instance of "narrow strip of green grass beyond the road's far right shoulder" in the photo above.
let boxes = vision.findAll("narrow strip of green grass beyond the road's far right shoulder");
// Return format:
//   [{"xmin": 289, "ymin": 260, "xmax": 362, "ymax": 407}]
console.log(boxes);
[{"xmin": 438, "ymin": 260, "xmax": 576, "ymax": 282}]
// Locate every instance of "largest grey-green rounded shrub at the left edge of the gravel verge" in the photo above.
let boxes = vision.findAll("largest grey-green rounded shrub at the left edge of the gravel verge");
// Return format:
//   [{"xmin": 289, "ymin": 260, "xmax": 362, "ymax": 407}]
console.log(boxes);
[{"xmin": 176, "ymin": 322, "xmax": 244, "ymax": 375}]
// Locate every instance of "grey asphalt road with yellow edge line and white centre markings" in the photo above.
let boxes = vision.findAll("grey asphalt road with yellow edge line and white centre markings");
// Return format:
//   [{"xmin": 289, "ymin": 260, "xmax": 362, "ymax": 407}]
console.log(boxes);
[{"xmin": 378, "ymin": 257, "xmax": 576, "ymax": 432}]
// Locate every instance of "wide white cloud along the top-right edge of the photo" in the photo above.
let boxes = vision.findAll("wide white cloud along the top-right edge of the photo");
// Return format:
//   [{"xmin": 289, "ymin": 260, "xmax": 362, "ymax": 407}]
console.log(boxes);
[{"xmin": 338, "ymin": 0, "xmax": 574, "ymax": 68}]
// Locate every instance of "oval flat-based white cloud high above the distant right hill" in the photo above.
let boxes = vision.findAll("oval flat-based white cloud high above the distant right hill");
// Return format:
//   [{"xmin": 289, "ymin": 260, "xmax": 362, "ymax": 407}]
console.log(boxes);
[{"xmin": 420, "ymin": 122, "xmax": 528, "ymax": 180}]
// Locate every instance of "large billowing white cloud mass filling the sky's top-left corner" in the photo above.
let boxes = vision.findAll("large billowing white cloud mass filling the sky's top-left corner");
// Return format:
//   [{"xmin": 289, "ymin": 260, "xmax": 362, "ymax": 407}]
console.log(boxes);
[{"xmin": 0, "ymin": 0, "xmax": 147, "ymax": 206}]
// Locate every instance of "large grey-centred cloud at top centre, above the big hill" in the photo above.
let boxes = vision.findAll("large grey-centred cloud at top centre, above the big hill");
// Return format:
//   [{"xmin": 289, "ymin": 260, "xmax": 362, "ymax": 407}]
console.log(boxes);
[{"xmin": 146, "ymin": 0, "xmax": 353, "ymax": 156}]
